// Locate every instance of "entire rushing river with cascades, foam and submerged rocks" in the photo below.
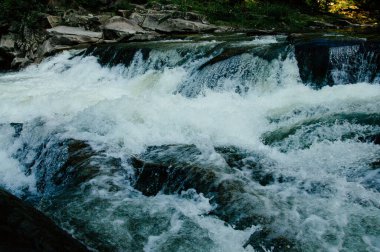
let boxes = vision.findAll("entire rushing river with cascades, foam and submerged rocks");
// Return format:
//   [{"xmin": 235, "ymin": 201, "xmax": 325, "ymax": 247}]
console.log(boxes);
[{"xmin": 0, "ymin": 36, "xmax": 380, "ymax": 251}]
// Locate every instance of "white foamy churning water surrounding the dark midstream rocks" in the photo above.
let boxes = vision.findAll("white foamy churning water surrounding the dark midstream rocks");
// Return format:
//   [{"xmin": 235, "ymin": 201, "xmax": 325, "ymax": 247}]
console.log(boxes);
[{"xmin": 0, "ymin": 37, "xmax": 380, "ymax": 251}]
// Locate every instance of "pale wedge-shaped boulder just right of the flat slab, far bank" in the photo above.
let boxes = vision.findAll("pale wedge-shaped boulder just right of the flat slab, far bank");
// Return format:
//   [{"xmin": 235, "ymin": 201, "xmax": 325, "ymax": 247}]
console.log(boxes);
[{"xmin": 103, "ymin": 17, "xmax": 145, "ymax": 40}]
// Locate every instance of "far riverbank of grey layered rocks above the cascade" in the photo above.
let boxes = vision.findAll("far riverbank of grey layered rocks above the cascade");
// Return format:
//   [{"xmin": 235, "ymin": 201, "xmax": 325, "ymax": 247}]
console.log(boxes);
[{"xmin": 0, "ymin": 3, "xmax": 378, "ymax": 70}]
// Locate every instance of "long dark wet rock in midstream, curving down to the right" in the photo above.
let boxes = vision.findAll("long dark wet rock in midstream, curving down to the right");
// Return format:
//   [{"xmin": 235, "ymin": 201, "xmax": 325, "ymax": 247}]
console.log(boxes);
[{"xmin": 130, "ymin": 145, "xmax": 271, "ymax": 229}]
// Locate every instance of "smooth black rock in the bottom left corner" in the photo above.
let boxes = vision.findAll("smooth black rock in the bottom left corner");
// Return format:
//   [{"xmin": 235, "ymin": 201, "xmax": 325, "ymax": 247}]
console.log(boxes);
[{"xmin": 0, "ymin": 189, "xmax": 89, "ymax": 252}]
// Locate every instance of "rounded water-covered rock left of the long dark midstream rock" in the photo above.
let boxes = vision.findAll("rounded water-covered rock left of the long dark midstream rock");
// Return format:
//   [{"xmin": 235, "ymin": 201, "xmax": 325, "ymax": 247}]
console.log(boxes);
[{"xmin": 31, "ymin": 139, "xmax": 120, "ymax": 195}]
